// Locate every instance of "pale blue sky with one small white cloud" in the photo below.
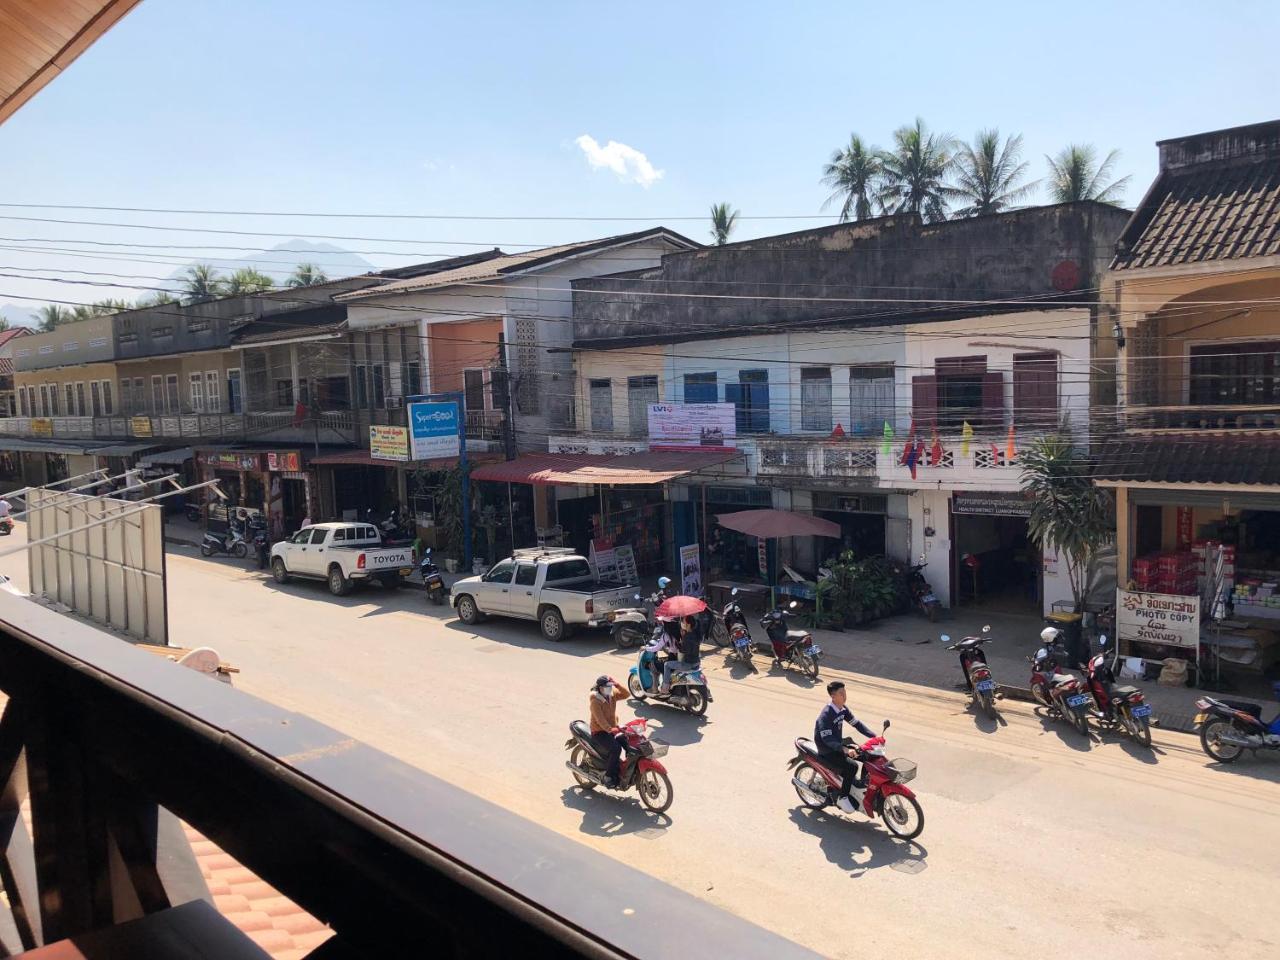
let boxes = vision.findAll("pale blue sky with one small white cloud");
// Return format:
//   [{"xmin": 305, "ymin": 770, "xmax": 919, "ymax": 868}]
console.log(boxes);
[{"xmin": 0, "ymin": 0, "xmax": 1280, "ymax": 323}]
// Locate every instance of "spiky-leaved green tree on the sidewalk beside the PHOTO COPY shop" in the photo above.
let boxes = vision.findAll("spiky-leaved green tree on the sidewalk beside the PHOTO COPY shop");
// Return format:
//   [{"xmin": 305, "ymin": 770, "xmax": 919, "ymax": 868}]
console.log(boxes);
[{"xmin": 1019, "ymin": 424, "xmax": 1115, "ymax": 612}]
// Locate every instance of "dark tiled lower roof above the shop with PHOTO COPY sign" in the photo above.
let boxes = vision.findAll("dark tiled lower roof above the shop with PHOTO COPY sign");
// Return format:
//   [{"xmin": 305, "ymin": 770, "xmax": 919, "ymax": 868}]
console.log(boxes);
[{"xmin": 1096, "ymin": 433, "xmax": 1280, "ymax": 486}]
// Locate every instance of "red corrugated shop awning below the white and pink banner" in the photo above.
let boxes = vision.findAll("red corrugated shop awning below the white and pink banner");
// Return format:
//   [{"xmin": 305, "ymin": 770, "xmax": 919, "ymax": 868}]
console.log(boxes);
[{"xmin": 471, "ymin": 451, "xmax": 741, "ymax": 486}]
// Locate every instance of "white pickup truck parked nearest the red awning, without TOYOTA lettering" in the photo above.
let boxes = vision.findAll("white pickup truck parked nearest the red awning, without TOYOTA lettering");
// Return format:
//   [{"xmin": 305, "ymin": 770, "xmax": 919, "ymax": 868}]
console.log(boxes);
[{"xmin": 449, "ymin": 548, "xmax": 636, "ymax": 640}]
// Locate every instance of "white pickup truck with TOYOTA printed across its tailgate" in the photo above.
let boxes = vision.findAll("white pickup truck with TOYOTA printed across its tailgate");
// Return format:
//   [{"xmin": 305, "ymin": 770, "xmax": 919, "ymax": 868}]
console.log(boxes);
[{"xmin": 271, "ymin": 522, "xmax": 413, "ymax": 596}]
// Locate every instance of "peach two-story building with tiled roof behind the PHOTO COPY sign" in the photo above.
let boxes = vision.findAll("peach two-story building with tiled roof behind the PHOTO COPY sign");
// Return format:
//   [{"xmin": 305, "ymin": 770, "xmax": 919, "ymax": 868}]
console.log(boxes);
[{"xmin": 1097, "ymin": 122, "xmax": 1280, "ymax": 669}]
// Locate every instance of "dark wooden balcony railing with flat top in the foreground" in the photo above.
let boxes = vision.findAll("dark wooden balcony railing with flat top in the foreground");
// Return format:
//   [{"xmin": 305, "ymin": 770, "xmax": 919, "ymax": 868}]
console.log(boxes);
[{"xmin": 0, "ymin": 593, "xmax": 815, "ymax": 960}]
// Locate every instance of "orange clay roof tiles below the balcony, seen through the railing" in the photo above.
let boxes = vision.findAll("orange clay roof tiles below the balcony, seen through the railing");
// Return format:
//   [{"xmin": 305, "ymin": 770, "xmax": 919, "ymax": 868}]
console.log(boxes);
[{"xmin": 186, "ymin": 827, "xmax": 333, "ymax": 960}]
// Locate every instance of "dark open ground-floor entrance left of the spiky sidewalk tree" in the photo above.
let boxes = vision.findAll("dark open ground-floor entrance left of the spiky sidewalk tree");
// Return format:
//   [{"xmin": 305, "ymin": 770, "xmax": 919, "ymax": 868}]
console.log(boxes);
[{"xmin": 951, "ymin": 493, "xmax": 1041, "ymax": 616}]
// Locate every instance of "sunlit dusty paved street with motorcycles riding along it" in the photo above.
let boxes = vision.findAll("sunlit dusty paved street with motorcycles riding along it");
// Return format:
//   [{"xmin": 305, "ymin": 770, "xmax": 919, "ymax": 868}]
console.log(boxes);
[{"xmin": 0, "ymin": 534, "xmax": 1280, "ymax": 957}]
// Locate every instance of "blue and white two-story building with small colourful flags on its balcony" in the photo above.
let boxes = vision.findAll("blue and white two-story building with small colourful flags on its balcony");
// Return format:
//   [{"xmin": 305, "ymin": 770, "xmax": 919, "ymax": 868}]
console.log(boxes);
[{"xmin": 565, "ymin": 204, "xmax": 1128, "ymax": 611}]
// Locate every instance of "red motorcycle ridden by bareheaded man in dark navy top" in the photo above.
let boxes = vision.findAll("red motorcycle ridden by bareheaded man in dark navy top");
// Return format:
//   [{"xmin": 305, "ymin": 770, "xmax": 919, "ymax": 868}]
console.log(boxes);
[{"xmin": 787, "ymin": 721, "xmax": 924, "ymax": 840}]
